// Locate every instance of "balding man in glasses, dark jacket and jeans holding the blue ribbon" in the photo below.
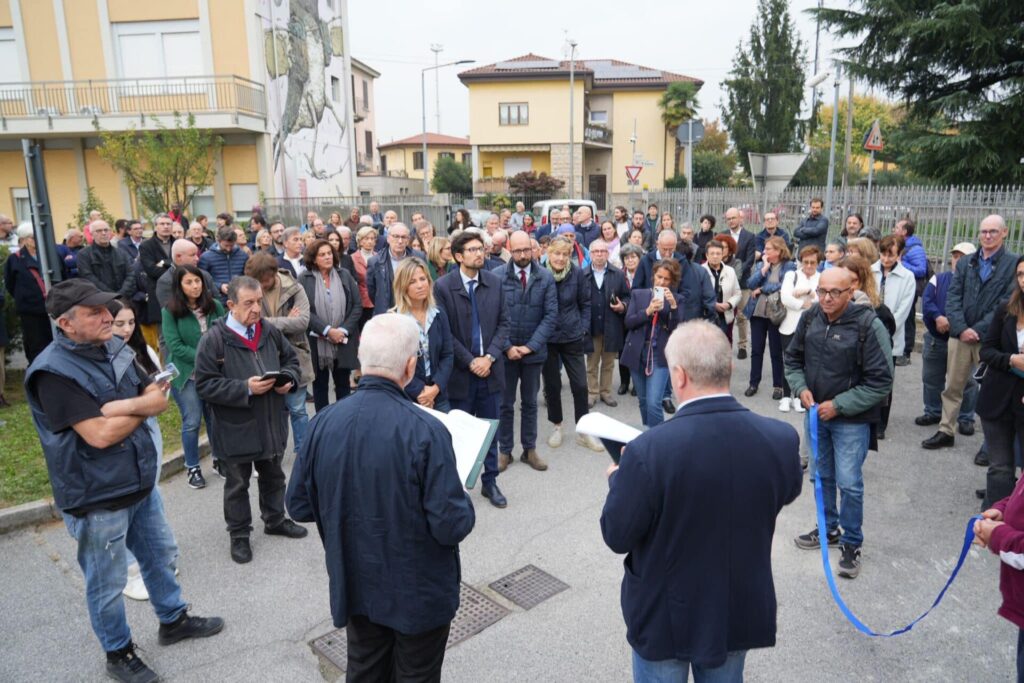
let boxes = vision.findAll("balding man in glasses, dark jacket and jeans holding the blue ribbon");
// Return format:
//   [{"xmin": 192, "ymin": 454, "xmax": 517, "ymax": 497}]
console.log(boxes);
[{"xmin": 785, "ymin": 268, "xmax": 893, "ymax": 579}]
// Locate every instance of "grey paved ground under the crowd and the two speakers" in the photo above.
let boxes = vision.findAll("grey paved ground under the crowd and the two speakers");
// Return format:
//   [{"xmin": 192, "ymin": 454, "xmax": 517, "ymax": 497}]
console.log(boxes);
[{"xmin": 0, "ymin": 355, "xmax": 1017, "ymax": 682}]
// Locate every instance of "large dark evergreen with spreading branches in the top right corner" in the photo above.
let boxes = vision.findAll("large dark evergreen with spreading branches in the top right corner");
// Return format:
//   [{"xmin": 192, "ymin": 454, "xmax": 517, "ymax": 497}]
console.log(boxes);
[{"xmin": 810, "ymin": 0, "xmax": 1024, "ymax": 183}]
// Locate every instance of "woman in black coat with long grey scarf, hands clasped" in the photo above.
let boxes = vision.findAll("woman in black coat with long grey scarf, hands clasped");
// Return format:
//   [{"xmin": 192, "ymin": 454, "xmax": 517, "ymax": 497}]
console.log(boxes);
[{"xmin": 299, "ymin": 240, "xmax": 362, "ymax": 413}]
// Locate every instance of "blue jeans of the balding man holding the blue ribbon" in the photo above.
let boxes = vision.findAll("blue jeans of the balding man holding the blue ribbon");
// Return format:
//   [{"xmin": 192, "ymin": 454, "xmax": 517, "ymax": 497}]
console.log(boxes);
[{"xmin": 804, "ymin": 414, "xmax": 871, "ymax": 548}]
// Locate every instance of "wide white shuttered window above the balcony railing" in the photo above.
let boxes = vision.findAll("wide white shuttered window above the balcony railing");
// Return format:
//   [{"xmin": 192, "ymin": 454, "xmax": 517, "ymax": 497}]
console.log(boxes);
[{"xmin": 113, "ymin": 19, "xmax": 204, "ymax": 78}]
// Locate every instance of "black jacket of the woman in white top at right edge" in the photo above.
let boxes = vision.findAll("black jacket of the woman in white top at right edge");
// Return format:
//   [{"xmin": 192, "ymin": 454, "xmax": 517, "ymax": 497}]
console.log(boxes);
[{"xmin": 975, "ymin": 303, "xmax": 1024, "ymax": 422}]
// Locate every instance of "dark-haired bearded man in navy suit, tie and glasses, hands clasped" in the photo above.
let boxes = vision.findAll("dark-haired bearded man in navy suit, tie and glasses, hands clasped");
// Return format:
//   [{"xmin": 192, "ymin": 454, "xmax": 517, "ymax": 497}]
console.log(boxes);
[{"xmin": 434, "ymin": 231, "xmax": 509, "ymax": 508}]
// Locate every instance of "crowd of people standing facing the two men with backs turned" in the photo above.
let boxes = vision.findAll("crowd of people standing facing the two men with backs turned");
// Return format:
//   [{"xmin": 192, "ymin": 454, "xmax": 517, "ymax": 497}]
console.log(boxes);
[{"xmin": 18, "ymin": 194, "xmax": 1024, "ymax": 680}]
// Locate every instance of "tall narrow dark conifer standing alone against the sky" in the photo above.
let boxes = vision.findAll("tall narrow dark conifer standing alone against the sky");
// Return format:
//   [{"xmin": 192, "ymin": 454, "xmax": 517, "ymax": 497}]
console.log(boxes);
[{"xmin": 722, "ymin": 0, "xmax": 807, "ymax": 172}]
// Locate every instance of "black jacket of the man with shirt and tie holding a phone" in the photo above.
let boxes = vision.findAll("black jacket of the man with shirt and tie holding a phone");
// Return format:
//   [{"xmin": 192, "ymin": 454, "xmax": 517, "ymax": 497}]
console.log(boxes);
[{"xmin": 196, "ymin": 318, "xmax": 301, "ymax": 462}]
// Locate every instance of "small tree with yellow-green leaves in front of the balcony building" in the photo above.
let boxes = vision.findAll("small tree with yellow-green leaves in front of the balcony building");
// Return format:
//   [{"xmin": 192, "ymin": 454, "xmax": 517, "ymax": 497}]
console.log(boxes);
[{"xmin": 96, "ymin": 112, "xmax": 224, "ymax": 213}]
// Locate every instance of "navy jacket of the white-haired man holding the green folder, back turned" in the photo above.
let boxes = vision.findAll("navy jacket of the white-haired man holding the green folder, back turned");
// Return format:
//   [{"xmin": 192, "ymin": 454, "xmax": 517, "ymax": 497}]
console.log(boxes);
[{"xmin": 287, "ymin": 375, "xmax": 476, "ymax": 633}]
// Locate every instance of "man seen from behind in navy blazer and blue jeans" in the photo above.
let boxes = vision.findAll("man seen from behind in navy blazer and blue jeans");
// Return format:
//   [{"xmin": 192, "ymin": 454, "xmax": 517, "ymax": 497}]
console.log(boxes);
[{"xmin": 601, "ymin": 321, "xmax": 802, "ymax": 681}]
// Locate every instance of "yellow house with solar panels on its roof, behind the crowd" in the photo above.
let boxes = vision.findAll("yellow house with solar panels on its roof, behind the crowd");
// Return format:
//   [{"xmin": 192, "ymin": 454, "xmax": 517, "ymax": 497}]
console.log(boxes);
[{"xmin": 459, "ymin": 54, "xmax": 703, "ymax": 206}]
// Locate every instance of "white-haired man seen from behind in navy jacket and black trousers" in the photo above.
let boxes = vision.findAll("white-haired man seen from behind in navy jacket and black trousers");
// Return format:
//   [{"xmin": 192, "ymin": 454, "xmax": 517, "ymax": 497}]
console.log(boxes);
[{"xmin": 288, "ymin": 313, "xmax": 476, "ymax": 681}]
